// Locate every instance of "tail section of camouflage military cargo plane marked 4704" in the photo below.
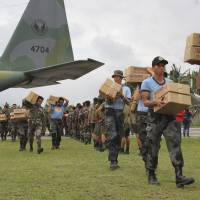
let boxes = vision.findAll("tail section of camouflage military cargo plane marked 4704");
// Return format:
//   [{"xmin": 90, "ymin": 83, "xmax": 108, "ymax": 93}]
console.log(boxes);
[{"xmin": 0, "ymin": 0, "xmax": 103, "ymax": 91}]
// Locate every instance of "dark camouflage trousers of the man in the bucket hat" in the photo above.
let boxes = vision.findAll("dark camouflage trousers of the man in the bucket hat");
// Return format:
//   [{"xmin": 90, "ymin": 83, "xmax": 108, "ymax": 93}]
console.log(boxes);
[{"xmin": 105, "ymin": 108, "xmax": 124, "ymax": 162}]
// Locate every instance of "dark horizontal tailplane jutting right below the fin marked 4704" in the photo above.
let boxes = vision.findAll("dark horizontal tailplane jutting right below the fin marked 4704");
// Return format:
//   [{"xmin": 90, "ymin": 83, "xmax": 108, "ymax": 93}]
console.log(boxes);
[{"xmin": 16, "ymin": 59, "xmax": 104, "ymax": 88}]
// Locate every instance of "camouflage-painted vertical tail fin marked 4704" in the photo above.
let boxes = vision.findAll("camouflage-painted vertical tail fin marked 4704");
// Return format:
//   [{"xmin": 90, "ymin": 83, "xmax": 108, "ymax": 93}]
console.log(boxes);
[{"xmin": 0, "ymin": 0, "xmax": 74, "ymax": 71}]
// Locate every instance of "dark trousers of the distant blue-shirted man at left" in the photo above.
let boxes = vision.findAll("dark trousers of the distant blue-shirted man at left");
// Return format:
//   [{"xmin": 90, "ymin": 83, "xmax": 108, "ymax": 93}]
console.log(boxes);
[{"xmin": 51, "ymin": 119, "xmax": 63, "ymax": 148}]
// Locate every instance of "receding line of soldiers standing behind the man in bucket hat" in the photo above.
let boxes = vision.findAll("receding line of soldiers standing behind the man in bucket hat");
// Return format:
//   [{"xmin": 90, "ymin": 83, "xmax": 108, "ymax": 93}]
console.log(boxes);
[{"xmin": 64, "ymin": 96, "xmax": 135, "ymax": 154}]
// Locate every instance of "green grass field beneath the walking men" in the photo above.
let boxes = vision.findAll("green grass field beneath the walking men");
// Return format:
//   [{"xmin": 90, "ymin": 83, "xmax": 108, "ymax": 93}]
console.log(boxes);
[{"xmin": 0, "ymin": 139, "xmax": 200, "ymax": 200}]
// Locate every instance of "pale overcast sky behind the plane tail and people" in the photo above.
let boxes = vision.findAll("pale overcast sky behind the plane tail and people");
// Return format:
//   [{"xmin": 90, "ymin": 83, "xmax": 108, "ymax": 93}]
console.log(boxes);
[{"xmin": 0, "ymin": 0, "xmax": 200, "ymax": 105}]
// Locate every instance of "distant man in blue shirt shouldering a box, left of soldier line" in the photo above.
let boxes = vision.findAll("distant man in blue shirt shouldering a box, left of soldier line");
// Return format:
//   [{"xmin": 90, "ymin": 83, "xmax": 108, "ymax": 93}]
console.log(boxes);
[{"xmin": 49, "ymin": 97, "xmax": 68, "ymax": 149}]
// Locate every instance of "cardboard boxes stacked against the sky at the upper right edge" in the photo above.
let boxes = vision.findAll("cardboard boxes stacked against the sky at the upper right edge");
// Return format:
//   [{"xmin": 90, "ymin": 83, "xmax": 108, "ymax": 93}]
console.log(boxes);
[{"xmin": 184, "ymin": 33, "xmax": 200, "ymax": 65}]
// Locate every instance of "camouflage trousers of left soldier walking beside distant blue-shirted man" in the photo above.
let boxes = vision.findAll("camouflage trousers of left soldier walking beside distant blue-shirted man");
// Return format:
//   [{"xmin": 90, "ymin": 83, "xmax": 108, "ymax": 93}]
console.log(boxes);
[{"xmin": 28, "ymin": 124, "xmax": 43, "ymax": 149}]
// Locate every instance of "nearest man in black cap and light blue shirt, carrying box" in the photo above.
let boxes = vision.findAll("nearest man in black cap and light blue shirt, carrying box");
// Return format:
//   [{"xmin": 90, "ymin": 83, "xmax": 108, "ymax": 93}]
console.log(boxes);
[{"xmin": 141, "ymin": 56, "xmax": 194, "ymax": 188}]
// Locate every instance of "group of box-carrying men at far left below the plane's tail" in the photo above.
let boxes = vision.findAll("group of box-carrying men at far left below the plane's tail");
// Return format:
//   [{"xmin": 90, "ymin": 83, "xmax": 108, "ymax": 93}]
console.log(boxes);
[{"xmin": 0, "ymin": 96, "xmax": 68, "ymax": 154}]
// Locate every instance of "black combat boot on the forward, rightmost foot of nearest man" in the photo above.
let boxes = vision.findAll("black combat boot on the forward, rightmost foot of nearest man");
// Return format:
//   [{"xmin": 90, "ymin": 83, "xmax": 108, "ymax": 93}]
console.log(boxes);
[{"xmin": 175, "ymin": 167, "xmax": 195, "ymax": 188}]
